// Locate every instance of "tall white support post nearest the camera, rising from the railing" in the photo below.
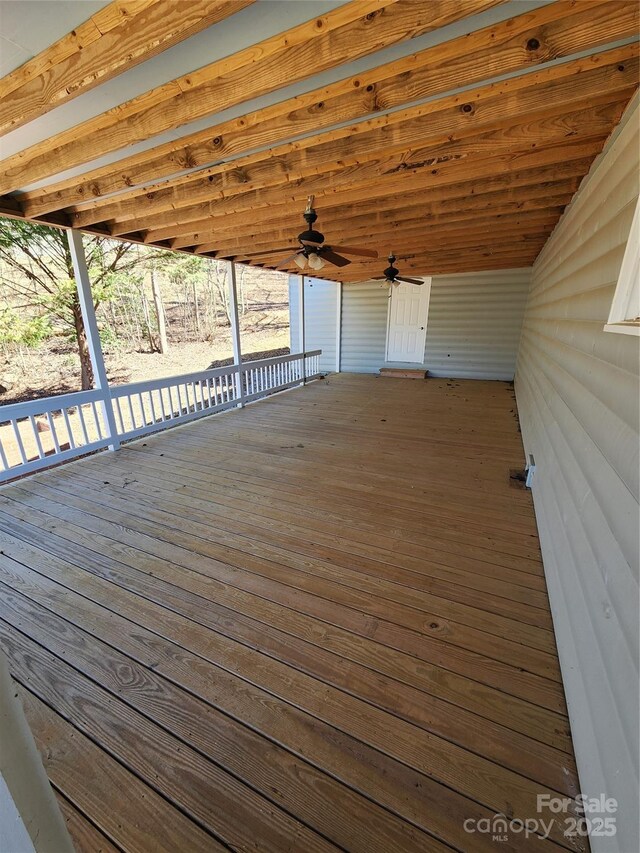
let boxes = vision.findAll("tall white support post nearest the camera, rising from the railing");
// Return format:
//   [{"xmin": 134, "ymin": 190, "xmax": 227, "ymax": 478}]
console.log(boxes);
[{"xmin": 67, "ymin": 229, "xmax": 120, "ymax": 450}]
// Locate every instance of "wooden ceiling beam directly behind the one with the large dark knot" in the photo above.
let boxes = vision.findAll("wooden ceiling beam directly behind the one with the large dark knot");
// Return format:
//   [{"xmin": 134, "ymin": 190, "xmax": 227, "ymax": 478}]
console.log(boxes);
[{"xmin": 65, "ymin": 50, "xmax": 639, "ymax": 225}]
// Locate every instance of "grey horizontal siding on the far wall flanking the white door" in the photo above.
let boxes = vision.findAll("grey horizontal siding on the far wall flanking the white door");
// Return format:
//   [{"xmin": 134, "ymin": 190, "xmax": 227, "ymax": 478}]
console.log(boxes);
[{"xmin": 342, "ymin": 269, "xmax": 531, "ymax": 379}]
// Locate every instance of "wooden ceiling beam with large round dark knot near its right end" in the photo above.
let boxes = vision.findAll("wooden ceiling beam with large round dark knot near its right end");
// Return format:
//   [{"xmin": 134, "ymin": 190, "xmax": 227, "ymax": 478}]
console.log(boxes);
[{"xmin": 17, "ymin": 2, "xmax": 637, "ymax": 215}]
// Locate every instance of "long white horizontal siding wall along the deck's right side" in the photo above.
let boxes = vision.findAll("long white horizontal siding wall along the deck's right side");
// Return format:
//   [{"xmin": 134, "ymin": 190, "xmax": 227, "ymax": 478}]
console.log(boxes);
[{"xmin": 516, "ymin": 98, "xmax": 640, "ymax": 853}]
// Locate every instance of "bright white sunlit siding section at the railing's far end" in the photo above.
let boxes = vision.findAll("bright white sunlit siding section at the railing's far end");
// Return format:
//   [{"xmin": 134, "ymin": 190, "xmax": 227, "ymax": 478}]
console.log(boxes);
[{"xmin": 289, "ymin": 275, "xmax": 340, "ymax": 373}]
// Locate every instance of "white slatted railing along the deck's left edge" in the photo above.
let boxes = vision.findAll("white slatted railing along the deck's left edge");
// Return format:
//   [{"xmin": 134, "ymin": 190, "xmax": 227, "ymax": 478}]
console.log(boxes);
[{"xmin": 0, "ymin": 350, "xmax": 322, "ymax": 482}]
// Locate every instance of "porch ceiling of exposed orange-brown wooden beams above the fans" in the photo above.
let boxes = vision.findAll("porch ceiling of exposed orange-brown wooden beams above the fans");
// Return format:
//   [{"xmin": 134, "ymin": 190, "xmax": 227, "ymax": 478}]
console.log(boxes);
[{"xmin": 0, "ymin": 0, "xmax": 638, "ymax": 281}]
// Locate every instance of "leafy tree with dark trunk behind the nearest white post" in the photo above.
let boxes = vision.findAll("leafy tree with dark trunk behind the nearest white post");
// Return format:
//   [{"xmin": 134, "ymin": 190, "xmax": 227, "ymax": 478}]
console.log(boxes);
[{"xmin": 0, "ymin": 218, "xmax": 141, "ymax": 391}]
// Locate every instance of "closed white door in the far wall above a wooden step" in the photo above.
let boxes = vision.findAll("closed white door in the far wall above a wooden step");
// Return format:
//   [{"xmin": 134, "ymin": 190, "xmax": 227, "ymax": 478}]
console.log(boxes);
[{"xmin": 387, "ymin": 278, "xmax": 431, "ymax": 364}]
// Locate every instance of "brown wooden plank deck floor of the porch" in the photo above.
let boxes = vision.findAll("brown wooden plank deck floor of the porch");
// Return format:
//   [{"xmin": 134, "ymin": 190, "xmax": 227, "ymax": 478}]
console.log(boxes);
[{"xmin": 0, "ymin": 374, "xmax": 582, "ymax": 853}]
